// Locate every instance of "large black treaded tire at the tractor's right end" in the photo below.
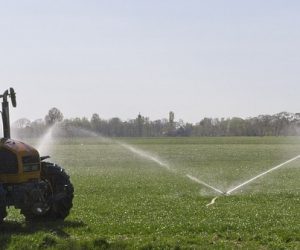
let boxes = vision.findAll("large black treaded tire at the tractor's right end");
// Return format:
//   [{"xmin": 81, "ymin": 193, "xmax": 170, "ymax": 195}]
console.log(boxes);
[{"xmin": 21, "ymin": 162, "xmax": 74, "ymax": 221}]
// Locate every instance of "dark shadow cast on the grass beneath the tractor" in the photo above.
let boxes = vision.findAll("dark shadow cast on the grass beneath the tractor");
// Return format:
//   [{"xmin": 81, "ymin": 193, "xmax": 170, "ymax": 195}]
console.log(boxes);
[{"xmin": 0, "ymin": 221, "xmax": 86, "ymax": 250}]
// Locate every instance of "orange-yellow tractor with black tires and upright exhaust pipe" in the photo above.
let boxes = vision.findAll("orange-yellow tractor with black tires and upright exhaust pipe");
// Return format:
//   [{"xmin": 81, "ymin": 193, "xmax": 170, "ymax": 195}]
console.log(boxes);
[{"xmin": 0, "ymin": 88, "xmax": 74, "ymax": 223}]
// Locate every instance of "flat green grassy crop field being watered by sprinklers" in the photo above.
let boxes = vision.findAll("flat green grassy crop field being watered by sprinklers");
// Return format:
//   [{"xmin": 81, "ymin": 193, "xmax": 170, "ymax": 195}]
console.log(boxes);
[{"xmin": 0, "ymin": 137, "xmax": 300, "ymax": 249}]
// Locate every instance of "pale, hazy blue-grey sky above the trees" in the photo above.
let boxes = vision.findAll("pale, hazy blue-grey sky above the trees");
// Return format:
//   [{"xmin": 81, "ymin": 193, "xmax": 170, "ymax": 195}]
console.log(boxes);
[{"xmin": 0, "ymin": 0, "xmax": 300, "ymax": 123}]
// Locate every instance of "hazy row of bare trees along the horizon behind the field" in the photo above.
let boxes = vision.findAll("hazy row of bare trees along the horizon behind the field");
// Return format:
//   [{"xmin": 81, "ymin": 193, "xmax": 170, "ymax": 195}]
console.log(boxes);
[{"xmin": 13, "ymin": 108, "xmax": 300, "ymax": 137}]
